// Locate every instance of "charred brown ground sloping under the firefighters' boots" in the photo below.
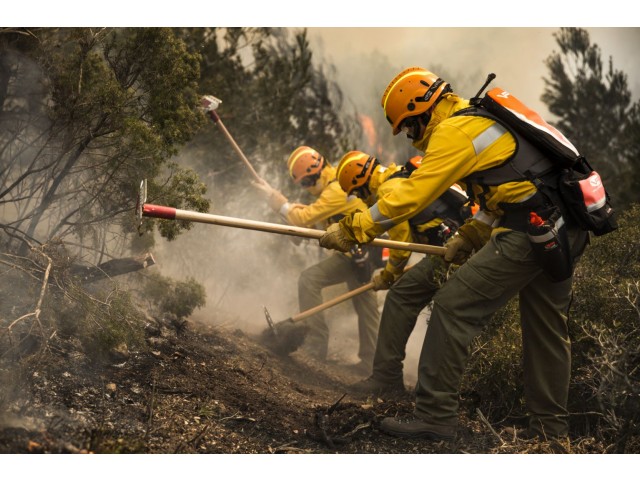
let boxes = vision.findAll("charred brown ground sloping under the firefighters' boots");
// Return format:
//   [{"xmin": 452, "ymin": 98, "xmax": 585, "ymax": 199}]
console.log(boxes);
[{"xmin": 0, "ymin": 316, "xmax": 616, "ymax": 454}]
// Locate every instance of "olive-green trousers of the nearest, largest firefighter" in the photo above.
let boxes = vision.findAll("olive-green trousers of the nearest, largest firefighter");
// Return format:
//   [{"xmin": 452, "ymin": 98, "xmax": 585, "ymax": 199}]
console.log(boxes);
[{"xmin": 415, "ymin": 230, "xmax": 586, "ymax": 437}]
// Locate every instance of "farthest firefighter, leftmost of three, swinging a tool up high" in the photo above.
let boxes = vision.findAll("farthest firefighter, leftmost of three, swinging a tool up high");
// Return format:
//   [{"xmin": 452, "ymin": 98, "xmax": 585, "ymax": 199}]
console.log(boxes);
[{"xmin": 255, "ymin": 146, "xmax": 380, "ymax": 375}]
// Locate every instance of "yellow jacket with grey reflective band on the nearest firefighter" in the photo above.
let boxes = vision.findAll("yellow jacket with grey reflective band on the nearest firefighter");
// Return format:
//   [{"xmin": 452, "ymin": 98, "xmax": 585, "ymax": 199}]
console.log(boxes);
[{"xmin": 343, "ymin": 94, "xmax": 536, "ymax": 243}]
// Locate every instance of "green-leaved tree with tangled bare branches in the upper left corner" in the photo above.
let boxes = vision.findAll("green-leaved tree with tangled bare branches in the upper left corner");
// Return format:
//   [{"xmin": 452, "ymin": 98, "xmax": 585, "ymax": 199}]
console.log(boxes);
[{"xmin": 0, "ymin": 28, "xmax": 208, "ymax": 260}]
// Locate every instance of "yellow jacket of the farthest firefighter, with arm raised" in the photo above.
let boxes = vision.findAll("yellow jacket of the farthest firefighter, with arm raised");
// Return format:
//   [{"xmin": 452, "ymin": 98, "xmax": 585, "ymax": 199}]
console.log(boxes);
[{"xmin": 284, "ymin": 165, "xmax": 367, "ymax": 228}]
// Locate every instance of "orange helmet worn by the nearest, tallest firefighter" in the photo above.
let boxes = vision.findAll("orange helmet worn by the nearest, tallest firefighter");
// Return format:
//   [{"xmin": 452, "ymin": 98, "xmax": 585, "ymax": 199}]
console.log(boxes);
[{"xmin": 382, "ymin": 67, "xmax": 451, "ymax": 135}]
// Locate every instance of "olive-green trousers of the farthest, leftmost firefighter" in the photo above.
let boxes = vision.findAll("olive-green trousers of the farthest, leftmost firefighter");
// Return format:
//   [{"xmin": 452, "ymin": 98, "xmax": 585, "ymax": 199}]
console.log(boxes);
[{"xmin": 298, "ymin": 253, "xmax": 380, "ymax": 365}]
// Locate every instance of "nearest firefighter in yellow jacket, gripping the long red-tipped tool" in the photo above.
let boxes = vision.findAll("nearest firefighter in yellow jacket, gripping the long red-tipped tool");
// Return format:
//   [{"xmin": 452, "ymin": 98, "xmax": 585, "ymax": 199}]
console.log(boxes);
[{"xmin": 320, "ymin": 67, "xmax": 588, "ymax": 440}]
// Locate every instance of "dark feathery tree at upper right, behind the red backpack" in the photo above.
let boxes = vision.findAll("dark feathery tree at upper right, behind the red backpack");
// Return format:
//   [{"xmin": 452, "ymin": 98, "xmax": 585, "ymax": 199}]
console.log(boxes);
[{"xmin": 542, "ymin": 28, "xmax": 640, "ymax": 209}]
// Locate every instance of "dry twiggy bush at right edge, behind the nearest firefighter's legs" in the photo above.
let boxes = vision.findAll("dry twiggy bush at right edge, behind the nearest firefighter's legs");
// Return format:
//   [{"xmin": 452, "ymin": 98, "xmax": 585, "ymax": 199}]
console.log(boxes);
[{"xmin": 570, "ymin": 204, "xmax": 640, "ymax": 453}]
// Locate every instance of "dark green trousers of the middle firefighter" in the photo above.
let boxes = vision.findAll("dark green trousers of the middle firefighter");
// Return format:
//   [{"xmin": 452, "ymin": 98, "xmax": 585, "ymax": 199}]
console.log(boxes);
[{"xmin": 373, "ymin": 256, "xmax": 444, "ymax": 383}]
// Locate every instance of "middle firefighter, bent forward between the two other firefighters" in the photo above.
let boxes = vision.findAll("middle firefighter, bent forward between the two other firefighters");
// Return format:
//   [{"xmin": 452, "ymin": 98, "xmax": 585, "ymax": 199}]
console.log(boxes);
[{"xmin": 337, "ymin": 151, "xmax": 471, "ymax": 396}]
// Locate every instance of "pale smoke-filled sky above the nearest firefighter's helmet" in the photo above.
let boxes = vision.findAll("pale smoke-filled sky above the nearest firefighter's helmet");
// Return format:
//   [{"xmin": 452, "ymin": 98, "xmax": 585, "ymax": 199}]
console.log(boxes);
[{"xmin": 309, "ymin": 27, "xmax": 640, "ymax": 118}]
